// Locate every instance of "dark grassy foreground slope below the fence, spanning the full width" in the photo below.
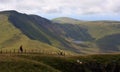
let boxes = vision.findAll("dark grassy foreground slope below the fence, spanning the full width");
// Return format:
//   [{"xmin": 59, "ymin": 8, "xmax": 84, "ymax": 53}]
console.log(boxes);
[{"xmin": 0, "ymin": 54, "xmax": 120, "ymax": 72}]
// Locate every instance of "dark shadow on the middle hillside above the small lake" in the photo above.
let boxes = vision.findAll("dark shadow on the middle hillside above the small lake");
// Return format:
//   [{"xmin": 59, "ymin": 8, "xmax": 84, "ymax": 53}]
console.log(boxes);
[{"xmin": 54, "ymin": 23, "xmax": 94, "ymax": 41}]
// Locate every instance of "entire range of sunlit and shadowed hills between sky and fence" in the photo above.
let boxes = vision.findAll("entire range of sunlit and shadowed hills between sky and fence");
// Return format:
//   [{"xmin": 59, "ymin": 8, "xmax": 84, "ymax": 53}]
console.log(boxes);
[{"xmin": 0, "ymin": 11, "xmax": 120, "ymax": 54}]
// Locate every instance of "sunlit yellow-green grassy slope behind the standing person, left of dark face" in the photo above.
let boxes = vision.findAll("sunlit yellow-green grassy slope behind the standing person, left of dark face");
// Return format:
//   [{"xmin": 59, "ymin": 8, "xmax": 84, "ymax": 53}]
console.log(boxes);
[{"xmin": 0, "ymin": 12, "xmax": 60, "ymax": 51}]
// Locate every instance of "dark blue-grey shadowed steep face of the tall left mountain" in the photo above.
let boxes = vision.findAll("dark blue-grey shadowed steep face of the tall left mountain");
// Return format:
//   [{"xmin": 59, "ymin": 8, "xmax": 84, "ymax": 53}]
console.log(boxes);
[{"xmin": 8, "ymin": 13, "xmax": 51, "ymax": 44}]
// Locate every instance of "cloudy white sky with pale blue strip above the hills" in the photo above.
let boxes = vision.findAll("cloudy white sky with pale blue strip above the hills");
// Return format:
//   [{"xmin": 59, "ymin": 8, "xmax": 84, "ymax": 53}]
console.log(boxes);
[{"xmin": 0, "ymin": 0, "xmax": 120, "ymax": 21}]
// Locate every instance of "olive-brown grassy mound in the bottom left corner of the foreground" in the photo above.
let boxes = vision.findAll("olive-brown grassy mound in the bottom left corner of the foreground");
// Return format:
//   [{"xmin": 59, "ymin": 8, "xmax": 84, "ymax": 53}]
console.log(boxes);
[{"xmin": 0, "ymin": 56, "xmax": 60, "ymax": 72}]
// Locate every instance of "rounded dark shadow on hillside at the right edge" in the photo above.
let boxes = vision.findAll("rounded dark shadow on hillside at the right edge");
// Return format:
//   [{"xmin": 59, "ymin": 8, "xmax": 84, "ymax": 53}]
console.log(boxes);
[{"xmin": 96, "ymin": 34, "xmax": 120, "ymax": 52}]
